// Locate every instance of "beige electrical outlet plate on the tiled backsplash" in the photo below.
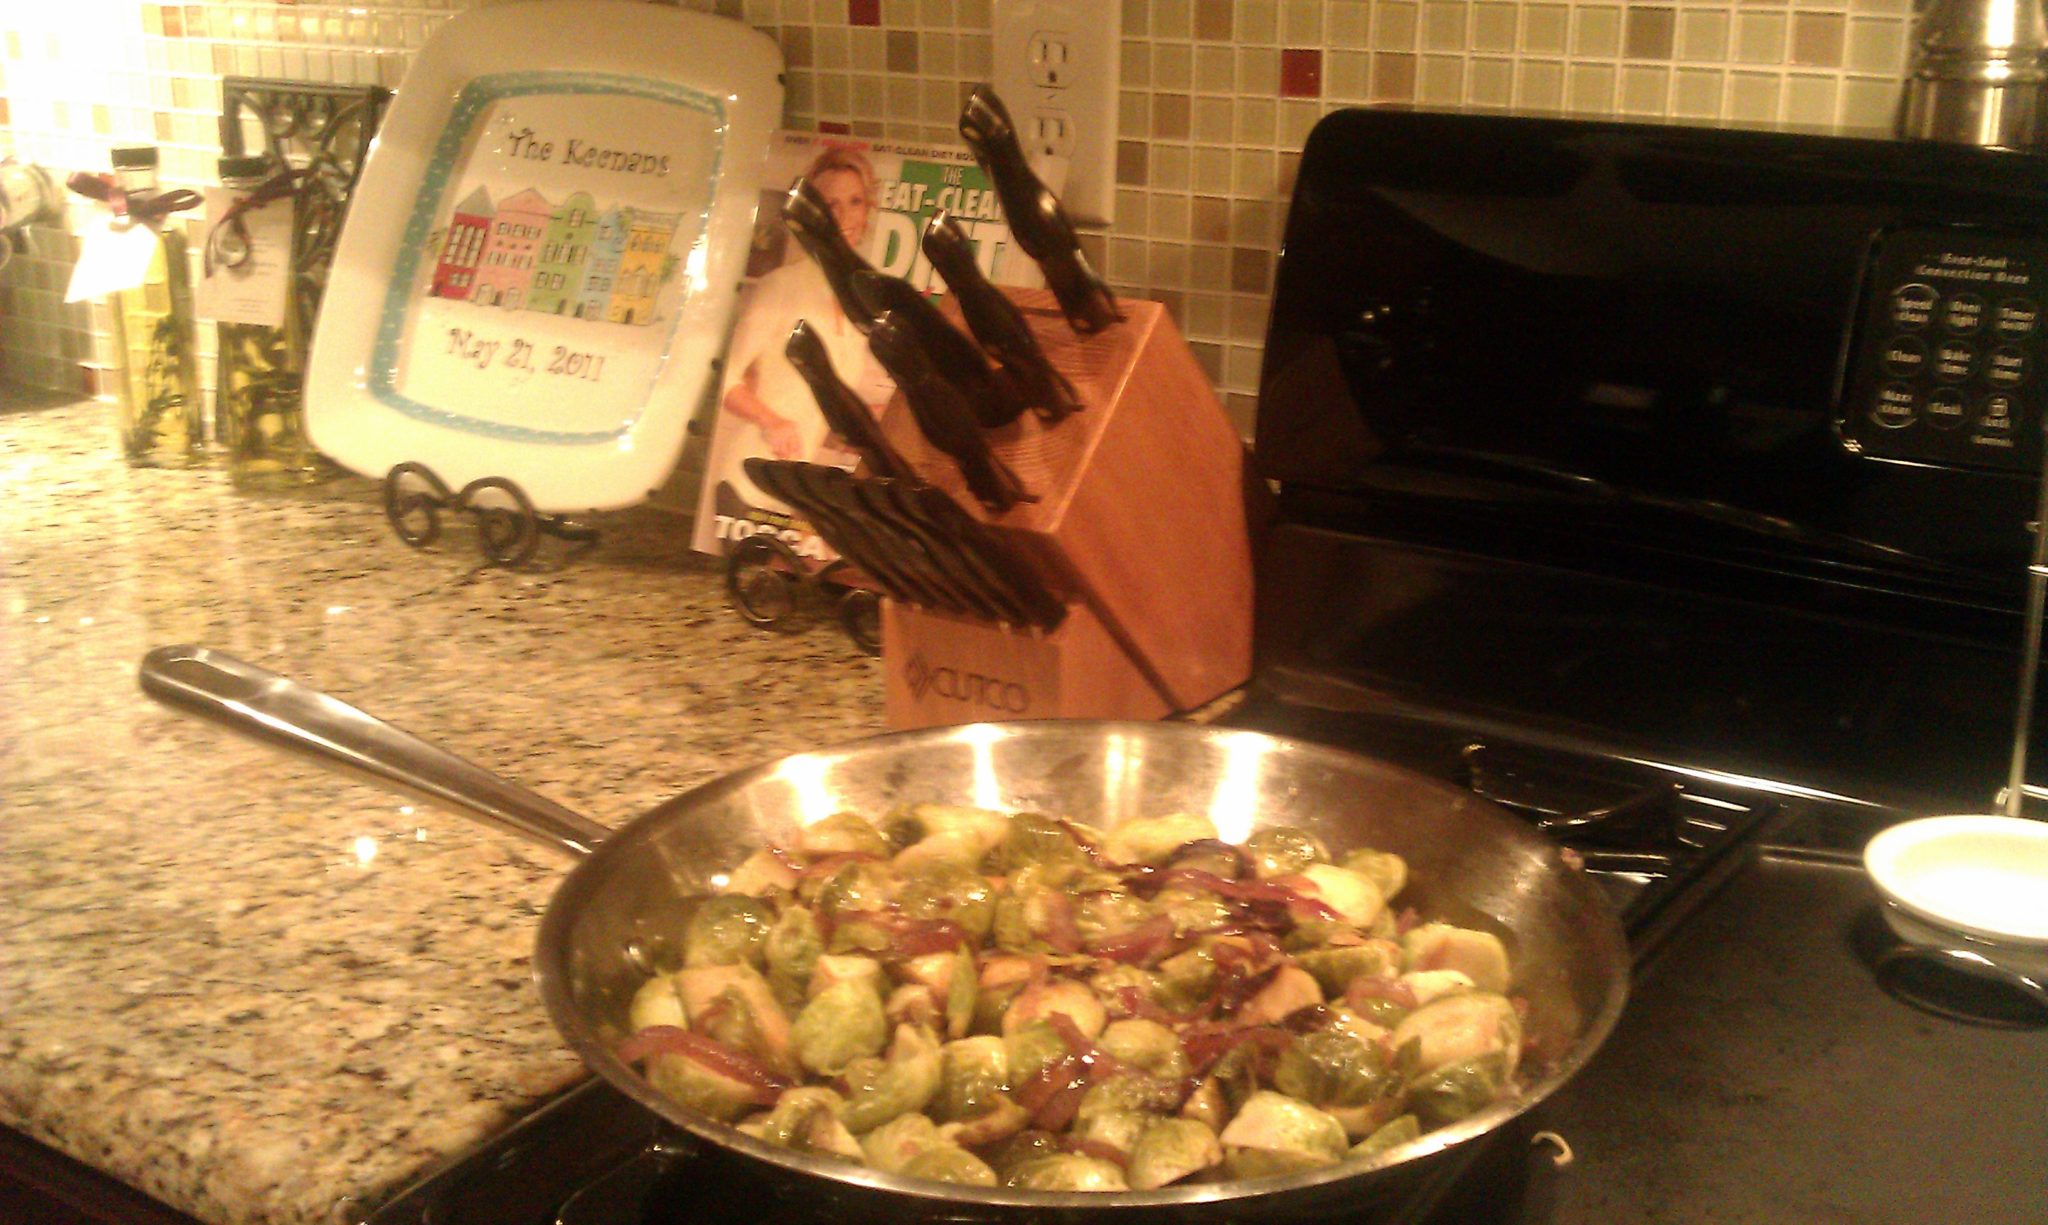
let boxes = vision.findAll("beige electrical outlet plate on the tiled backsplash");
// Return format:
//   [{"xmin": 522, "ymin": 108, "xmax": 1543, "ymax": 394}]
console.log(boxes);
[{"xmin": 989, "ymin": 0, "xmax": 1124, "ymax": 225}]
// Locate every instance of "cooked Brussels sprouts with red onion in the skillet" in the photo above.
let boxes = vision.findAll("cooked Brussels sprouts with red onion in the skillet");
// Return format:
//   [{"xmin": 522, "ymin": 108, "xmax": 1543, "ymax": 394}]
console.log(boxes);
[{"xmin": 621, "ymin": 805, "xmax": 1522, "ymax": 1190}]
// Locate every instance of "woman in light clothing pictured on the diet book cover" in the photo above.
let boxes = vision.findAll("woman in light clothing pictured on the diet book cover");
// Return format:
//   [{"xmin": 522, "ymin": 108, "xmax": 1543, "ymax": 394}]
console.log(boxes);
[{"xmin": 709, "ymin": 145, "xmax": 891, "ymax": 516}]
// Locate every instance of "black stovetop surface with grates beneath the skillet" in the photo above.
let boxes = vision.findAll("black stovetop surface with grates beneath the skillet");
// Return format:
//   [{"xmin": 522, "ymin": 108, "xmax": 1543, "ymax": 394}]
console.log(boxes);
[{"xmin": 371, "ymin": 694, "xmax": 1966, "ymax": 1225}]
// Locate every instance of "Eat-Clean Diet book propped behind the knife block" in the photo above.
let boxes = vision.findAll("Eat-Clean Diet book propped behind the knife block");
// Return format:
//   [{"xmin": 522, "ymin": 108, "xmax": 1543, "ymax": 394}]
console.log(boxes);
[{"xmin": 690, "ymin": 131, "xmax": 1044, "ymax": 563}]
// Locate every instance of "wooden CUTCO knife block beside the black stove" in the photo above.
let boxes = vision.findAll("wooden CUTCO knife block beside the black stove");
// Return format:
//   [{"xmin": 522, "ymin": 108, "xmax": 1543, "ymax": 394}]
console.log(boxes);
[{"xmin": 883, "ymin": 289, "xmax": 1251, "ymax": 727}]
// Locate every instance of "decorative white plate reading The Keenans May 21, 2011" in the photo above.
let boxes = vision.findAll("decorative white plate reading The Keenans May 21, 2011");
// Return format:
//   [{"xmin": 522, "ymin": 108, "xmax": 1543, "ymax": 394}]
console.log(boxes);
[{"xmin": 305, "ymin": 0, "xmax": 782, "ymax": 512}]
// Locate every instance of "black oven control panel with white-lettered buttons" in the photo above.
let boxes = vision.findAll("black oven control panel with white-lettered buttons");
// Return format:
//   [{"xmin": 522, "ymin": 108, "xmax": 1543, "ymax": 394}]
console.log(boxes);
[{"xmin": 1839, "ymin": 227, "xmax": 2048, "ymax": 473}]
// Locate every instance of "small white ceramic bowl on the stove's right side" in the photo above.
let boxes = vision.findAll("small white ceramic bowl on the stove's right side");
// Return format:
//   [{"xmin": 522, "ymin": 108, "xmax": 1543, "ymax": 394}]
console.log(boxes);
[{"xmin": 1864, "ymin": 815, "xmax": 2048, "ymax": 946}]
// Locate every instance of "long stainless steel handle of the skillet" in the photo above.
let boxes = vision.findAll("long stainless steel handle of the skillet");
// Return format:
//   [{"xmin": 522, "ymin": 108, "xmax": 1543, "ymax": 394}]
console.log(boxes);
[{"xmin": 141, "ymin": 645, "xmax": 610, "ymax": 854}]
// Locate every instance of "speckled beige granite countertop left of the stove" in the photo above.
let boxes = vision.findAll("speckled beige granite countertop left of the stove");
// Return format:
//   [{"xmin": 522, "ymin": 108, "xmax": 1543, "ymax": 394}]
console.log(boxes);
[{"xmin": 0, "ymin": 391, "xmax": 881, "ymax": 1225}]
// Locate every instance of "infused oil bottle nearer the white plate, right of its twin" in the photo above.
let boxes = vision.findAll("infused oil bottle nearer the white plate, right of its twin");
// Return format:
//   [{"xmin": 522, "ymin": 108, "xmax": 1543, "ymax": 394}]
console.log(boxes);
[{"xmin": 215, "ymin": 156, "xmax": 334, "ymax": 490}]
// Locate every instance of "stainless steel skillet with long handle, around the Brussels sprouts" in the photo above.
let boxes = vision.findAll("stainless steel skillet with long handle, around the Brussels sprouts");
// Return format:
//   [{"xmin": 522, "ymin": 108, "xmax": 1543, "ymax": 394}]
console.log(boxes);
[{"xmin": 141, "ymin": 645, "xmax": 1628, "ymax": 1221}]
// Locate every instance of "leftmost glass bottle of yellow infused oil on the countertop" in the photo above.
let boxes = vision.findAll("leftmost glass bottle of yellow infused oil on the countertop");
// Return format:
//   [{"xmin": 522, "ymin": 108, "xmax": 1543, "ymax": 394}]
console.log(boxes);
[{"xmin": 109, "ymin": 145, "xmax": 205, "ymax": 467}]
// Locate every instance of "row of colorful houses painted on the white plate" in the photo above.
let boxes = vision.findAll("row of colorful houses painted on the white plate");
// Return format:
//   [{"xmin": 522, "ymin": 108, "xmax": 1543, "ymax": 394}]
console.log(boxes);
[{"xmin": 428, "ymin": 186, "xmax": 678, "ymax": 324}]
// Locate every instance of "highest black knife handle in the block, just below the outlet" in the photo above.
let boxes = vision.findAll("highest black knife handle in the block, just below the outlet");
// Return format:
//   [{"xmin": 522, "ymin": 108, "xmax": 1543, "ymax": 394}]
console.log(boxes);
[{"xmin": 961, "ymin": 84, "xmax": 1122, "ymax": 334}]
